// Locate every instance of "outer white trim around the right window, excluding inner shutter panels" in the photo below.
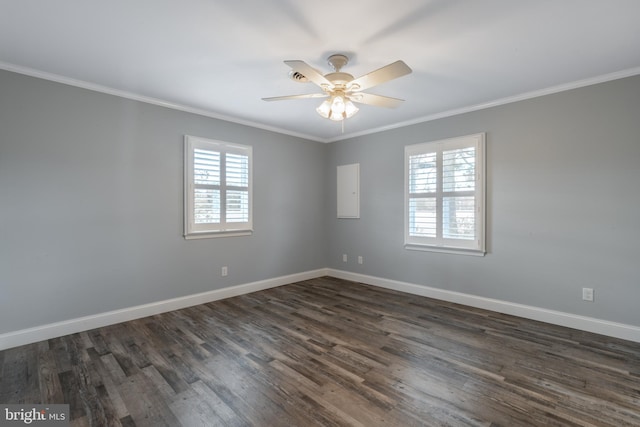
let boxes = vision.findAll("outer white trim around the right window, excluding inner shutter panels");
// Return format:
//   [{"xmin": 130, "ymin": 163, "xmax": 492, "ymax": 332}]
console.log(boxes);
[{"xmin": 404, "ymin": 133, "xmax": 486, "ymax": 256}]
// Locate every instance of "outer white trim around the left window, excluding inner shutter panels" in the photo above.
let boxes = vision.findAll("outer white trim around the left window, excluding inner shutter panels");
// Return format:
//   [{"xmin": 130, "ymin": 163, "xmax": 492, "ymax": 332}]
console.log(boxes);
[{"xmin": 184, "ymin": 135, "xmax": 253, "ymax": 240}]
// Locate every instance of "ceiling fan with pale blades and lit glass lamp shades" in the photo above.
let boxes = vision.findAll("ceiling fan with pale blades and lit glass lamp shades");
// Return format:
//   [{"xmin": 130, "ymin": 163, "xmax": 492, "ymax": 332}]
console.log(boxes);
[{"xmin": 262, "ymin": 54, "xmax": 411, "ymax": 121}]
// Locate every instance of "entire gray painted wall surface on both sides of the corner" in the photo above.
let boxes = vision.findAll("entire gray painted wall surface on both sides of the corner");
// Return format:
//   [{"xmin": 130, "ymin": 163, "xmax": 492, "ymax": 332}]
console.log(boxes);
[{"xmin": 0, "ymin": 71, "xmax": 640, "ymax": 333}]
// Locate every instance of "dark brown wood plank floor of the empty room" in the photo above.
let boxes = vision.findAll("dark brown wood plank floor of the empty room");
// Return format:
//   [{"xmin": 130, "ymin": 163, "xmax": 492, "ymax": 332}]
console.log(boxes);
[{"xmin": 0, "ymin": 277, "xmax": 640, "ymax": 427}]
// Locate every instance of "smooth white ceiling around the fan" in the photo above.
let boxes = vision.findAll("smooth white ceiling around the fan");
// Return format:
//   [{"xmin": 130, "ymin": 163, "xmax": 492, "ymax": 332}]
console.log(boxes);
[{"xmin": 0, "ymin": 0, "xmax": 640, "ymax": 142}]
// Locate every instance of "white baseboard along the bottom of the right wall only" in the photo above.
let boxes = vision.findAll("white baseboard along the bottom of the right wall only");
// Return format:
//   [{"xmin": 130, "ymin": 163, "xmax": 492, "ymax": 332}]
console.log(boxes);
[{"xmin": 327, "ymin": 269, "xmax": 640, "ymax": 342}]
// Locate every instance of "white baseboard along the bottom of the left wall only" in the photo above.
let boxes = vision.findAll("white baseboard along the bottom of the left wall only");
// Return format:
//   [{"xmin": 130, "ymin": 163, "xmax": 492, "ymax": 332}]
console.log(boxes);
[{"xmin": 0, "ymin": 268, "xmax": 328, "ymax": 350}]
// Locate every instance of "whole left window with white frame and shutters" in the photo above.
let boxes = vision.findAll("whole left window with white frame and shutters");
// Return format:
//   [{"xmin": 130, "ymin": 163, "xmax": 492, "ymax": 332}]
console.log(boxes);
[{"xmin": 184, "ymin": 136, "xmax": 252, "ymax": 239}]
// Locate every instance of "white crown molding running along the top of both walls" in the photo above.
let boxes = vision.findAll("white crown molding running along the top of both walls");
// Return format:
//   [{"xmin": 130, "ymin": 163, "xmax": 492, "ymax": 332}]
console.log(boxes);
[{"xmin": 0, "ymin": 61, "xmax": 640, "ymax": 143}]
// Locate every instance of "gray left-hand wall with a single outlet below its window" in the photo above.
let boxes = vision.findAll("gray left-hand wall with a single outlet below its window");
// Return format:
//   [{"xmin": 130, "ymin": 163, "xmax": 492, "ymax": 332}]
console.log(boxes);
[{"xmin": 0, "ymin": 71, "xmax": 327, "ymax": 333}]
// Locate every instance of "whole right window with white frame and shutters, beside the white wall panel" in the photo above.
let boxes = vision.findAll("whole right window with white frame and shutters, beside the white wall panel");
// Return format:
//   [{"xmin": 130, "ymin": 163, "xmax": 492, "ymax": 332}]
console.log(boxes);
[{"xmin": 405, "ymin": 133, "xmax": 485, "ymax": 255}]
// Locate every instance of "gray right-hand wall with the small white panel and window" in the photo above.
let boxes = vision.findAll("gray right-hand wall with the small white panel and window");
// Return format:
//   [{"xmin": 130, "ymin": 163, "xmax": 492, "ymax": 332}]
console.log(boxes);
[{"xmin": 327, "ymin": 76, "xmax": 640, "ymax": 325}]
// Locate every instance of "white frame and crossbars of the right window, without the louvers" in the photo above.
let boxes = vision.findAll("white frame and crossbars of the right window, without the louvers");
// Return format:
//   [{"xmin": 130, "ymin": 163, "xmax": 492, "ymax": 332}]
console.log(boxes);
[{"xmin": 404, "ymin": 133, "xmax": 486, "ymax": 256}]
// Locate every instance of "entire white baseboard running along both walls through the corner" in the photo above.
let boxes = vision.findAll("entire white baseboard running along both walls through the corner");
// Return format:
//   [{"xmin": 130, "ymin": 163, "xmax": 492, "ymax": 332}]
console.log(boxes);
[{"xmin": 0, "ymin": 268, "xmax": 640, "ymax": 350}]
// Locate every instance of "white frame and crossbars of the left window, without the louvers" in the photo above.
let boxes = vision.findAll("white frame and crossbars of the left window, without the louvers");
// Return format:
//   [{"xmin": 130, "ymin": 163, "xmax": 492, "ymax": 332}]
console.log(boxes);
[{"xmin": 184, "ymin": 135, "xmax": 253, "ymax": 239}]
